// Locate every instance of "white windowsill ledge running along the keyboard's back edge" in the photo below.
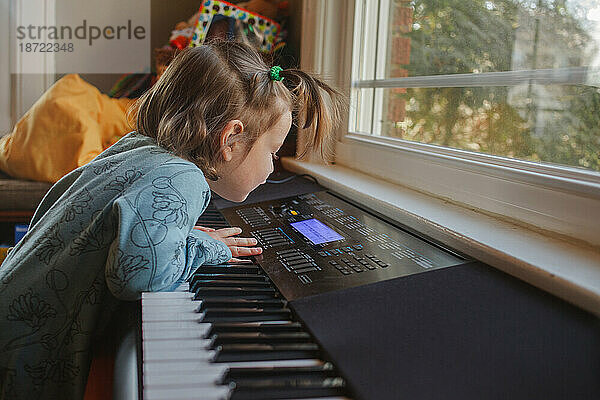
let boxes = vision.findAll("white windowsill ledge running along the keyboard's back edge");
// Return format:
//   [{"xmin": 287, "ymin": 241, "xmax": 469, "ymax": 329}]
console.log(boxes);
[{"xmin": 282, "ymin": 157, "xmax": 600, "ymax": 315}]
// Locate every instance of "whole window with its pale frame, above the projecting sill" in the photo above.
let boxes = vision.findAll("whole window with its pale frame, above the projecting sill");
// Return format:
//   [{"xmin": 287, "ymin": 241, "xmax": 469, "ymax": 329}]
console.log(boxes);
[{"xmin": 301, "ymin": 0, "xmax": 600, "ymax": 246}]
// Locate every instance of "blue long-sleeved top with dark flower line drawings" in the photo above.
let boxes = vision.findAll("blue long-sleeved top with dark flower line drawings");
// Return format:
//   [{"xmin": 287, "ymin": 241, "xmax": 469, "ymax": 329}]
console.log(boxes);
[{"xmin": 0, "ymin": 132, "xmax": 231, "ymax": 400}]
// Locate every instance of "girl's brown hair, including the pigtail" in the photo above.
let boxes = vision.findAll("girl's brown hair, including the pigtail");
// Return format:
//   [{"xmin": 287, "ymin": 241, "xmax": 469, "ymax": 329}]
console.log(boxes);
[{"xmin": 131, "ymin": 41, "xmax": 343, "ymax": 180}]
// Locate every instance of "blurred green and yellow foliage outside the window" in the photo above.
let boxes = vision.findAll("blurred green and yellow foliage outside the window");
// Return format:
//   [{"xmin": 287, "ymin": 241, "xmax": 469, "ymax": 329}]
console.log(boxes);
[{"xmin": 382, "ymin": 0, "xmax": 600, "ymax": 171}]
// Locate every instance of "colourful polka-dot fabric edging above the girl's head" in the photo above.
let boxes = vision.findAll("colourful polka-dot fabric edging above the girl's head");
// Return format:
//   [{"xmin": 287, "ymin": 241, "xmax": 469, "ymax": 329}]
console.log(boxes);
[{"xmin": 190, "ymin": 0, "xmax": 281, "ymax": 52}]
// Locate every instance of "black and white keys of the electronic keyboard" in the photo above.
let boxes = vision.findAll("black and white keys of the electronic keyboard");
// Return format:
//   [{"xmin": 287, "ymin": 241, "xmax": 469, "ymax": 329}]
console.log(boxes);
[{"xmin": 142, "ymin": 278, "xmax": 349, "ymax": 400}]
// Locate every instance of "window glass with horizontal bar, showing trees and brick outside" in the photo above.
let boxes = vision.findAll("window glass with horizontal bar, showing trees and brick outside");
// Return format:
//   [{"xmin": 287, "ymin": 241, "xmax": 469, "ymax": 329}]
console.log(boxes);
[{"xmin": 350, "ymin": 0, "xmax": 600, "ymax": 171}]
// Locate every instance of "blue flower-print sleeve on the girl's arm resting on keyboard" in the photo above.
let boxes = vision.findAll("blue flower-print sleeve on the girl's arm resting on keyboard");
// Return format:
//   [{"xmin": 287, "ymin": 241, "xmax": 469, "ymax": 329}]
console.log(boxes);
[{"xmin": 105, "ymin": 163, "xmax": 231, "ymax": 300}]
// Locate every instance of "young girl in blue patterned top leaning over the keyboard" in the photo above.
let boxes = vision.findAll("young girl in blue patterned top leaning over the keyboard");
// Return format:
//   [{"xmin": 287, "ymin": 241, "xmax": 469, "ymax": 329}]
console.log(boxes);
[{"xmin": 0, "ymin": 42, "xmax": 339, "ymax": 399}]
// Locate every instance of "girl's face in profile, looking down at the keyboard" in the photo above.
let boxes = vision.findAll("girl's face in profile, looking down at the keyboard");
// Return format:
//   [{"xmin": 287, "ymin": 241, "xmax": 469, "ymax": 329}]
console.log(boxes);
[{"xmin": 208, "ymin": 111, "xmax": 292, "ymax": 202}]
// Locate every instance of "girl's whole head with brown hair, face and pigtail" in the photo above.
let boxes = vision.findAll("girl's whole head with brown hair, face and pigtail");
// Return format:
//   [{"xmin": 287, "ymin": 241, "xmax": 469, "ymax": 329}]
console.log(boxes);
[{"xmin": 136, "ymin": 41, "xmax": 341, "ymax": 201}]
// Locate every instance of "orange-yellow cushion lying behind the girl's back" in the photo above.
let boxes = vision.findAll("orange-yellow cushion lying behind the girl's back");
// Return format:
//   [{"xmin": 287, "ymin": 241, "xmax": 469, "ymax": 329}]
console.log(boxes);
[{"xmin": 0, "ymin": 74, "xmax": 134, "ymax": 182}]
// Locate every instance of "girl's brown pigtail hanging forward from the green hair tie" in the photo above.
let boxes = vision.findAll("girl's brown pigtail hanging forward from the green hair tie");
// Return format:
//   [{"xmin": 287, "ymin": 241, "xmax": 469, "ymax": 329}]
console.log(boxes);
[{"xmin": 279, "ymin": 68, "xmax": 345, "ymax": 160}]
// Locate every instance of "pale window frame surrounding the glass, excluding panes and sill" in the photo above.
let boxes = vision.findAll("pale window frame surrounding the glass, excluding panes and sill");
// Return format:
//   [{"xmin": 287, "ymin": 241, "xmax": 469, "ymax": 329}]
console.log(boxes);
[{"xmin": 301, "ymin": 0, "xmax": 600, "ymax": 246}]
